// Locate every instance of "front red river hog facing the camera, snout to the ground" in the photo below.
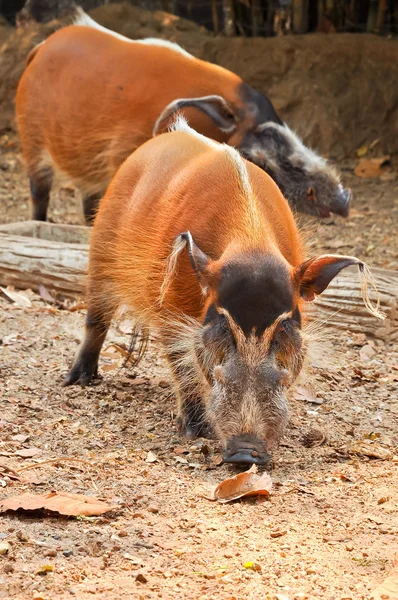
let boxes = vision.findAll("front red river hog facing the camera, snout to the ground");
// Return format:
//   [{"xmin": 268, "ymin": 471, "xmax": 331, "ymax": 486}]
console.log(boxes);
[{"xmin": 65, "ymin": 119, "xmax": 378, "ymax": 464}]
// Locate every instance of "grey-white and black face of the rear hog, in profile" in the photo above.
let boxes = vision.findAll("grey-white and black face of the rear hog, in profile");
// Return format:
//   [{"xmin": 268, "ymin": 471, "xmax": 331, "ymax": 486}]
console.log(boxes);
[{"xmin": 239, "ymin": 122, "xmax": 351, "ymax": 217}]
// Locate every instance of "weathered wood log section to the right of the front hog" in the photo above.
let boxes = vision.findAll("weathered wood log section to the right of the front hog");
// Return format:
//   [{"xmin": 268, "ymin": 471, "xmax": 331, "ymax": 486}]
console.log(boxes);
[{"xmin": 308, "ymin": 267, "xmax": 398, "ymax": 342}]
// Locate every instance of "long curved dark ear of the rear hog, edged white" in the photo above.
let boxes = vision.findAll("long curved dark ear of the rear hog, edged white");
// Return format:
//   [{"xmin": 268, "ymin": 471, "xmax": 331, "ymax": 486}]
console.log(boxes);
[{"xmin": 153, "ymin": 95, "xmax": 237, "ymax": 136}]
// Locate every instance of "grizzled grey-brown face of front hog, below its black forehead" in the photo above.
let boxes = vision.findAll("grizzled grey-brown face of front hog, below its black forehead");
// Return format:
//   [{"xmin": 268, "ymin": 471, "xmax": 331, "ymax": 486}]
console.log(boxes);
[{"xmin": 203, "ymin": 308, "xmax": 305, "ymax": 464}]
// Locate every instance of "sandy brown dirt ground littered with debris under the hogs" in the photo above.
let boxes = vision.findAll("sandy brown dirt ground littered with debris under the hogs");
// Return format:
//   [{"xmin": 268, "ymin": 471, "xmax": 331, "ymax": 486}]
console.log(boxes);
[{"xmin": 0, "ymin": 134, "xmax": 398, "ymax": 600}]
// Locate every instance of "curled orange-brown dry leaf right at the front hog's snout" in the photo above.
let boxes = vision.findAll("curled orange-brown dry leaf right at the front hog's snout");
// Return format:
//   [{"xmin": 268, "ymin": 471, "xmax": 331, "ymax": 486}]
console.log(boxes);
[{"xmin": 213, "ymin": 465, "xmax": 272, "ymax": 503}]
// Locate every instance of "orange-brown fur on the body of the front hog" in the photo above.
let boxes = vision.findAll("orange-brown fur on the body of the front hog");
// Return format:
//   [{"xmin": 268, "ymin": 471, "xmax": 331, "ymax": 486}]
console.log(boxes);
[{"xmin": 90, "ymin": 131, "xmax": 304, "ymax": 323}]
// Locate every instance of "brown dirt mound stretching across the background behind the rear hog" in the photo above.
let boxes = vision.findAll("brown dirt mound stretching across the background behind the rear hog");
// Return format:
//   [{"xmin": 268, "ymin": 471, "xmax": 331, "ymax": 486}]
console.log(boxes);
[{"xmin": 0, "ymin": 4, "xmax": 398, "ymax": 156}]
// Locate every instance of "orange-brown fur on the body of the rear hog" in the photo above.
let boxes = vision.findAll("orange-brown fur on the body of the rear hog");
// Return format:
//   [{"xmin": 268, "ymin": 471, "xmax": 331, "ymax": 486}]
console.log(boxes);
[{"xmin": 16, "ymin": 26, "xmax": 242, "ymax": 199}]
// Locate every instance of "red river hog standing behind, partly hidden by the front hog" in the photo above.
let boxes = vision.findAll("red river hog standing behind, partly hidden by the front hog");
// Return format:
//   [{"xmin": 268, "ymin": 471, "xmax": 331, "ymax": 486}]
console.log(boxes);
[{"xmin": 16, "ymin": 9, "xmax": 351, "ymax": 223}]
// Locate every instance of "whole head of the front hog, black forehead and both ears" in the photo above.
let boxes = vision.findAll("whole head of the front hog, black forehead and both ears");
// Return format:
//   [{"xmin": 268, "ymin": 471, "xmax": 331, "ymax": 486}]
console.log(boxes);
[{"xmin": 183, "ymin": 232, "xmax": 362, "ymax": 464}]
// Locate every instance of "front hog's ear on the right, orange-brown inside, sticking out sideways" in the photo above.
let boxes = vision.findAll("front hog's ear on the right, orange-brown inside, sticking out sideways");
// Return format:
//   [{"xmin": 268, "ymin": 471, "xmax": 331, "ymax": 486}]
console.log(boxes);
[{"xmin": 294, "ymin": 254, "xmax": 364, "ymax": 301}]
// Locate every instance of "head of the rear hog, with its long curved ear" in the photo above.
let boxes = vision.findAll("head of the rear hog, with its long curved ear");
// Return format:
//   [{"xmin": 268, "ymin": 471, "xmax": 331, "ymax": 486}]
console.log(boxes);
[{"xmin": 154, "ymin": 96, "xmax": 351, "ymax": 217}]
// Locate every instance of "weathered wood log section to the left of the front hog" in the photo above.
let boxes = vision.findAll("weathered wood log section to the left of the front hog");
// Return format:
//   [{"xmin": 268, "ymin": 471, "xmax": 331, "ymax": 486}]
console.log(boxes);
[{"xmin": 0, "ymin": 221, "xmax": 90, "ymax": 296}]
